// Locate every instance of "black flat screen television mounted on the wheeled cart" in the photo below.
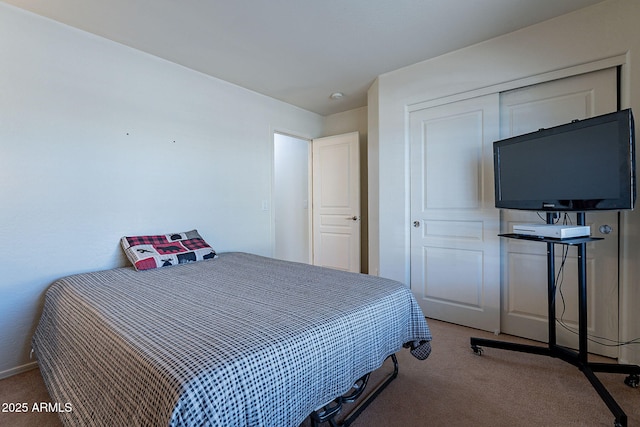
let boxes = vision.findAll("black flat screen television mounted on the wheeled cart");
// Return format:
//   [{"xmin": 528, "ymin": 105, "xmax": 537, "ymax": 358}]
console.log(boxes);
[{"xmin": 493, "ymin": 109, "xmax": 636, "ymax": 211}]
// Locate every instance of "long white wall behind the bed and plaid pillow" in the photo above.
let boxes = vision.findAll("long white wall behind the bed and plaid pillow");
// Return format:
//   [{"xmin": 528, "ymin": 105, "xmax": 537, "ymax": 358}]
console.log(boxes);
[{"xmin": 0, "ymin": 3, "xmax": 324, "ymax": 377}]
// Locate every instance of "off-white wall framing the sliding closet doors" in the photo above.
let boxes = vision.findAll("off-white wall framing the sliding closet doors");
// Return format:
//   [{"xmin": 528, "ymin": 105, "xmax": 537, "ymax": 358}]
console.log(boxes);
[{"xmin": 369, "ymin": 0, "xmax": 640, "ymax": 363}]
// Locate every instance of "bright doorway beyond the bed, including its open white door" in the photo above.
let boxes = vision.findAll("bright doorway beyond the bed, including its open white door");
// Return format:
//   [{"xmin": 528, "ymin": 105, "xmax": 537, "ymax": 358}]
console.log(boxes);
[{"xmin": 272, "ymin": 132, "xmax": 362, "ymax": 272}]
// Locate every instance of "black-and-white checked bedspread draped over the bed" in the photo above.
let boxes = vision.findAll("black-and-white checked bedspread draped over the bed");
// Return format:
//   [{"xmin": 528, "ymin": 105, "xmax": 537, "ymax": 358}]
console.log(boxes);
[{"xmin": 32, "ymin": 244, "xmax": 431, "ymax": 427}]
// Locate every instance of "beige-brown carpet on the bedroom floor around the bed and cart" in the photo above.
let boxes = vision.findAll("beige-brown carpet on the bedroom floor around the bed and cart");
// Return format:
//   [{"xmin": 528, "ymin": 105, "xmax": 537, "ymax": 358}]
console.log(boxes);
[{"xmin": 0, "ymin": 320, "xmax": 640, "ymax": 427}]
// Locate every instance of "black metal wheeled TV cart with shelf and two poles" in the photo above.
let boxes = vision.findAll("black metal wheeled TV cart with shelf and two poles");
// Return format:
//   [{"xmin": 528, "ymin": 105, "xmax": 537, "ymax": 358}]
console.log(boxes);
[{"xmin": 471, "ymin": 212, "xmax": 640, "ymax": 427}]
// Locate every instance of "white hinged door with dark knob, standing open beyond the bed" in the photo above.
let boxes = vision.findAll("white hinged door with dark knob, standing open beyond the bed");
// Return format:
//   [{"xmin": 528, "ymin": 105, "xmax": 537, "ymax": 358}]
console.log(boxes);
[{"xmin": 312, "ymin": 132, "xmax": 360, "ymax": 272}]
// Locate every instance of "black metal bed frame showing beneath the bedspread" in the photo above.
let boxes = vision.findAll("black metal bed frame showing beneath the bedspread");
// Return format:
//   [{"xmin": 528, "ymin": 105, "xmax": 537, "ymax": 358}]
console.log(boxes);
[{"xmin": 311, "ymin": 354, "xmax": 398, "ymax": 427}]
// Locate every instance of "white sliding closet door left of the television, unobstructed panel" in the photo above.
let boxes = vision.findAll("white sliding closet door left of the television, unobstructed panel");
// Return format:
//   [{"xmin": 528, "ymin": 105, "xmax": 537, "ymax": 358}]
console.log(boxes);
[{"xmin": 409, "ymin": 94, "xmax": 500, "ymax": 332}]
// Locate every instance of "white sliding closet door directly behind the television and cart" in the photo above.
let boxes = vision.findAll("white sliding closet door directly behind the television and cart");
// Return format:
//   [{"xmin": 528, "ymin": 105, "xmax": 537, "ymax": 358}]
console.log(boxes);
[{"xmin": 500, "ymin": 69, "xmax": 618, "ymax": 357}]
